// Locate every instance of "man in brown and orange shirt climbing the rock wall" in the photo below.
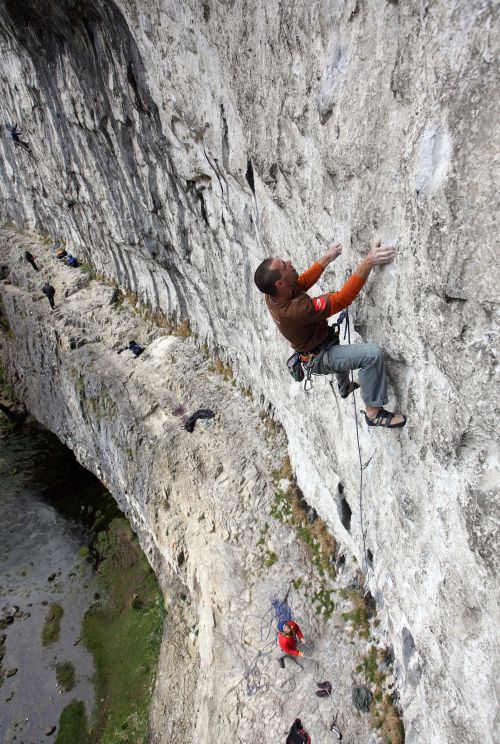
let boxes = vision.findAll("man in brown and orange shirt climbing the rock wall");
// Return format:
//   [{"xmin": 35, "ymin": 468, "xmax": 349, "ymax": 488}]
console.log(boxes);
[{"xmin": 254, "ymin": 241, "xmax": 406, "ymax": 429}]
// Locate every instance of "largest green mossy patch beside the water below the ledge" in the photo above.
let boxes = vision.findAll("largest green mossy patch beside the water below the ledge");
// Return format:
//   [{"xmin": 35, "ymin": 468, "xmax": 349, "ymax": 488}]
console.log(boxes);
[{"xmin": 82, "ymin": 518, "xmax": 164, "ymax": 744}]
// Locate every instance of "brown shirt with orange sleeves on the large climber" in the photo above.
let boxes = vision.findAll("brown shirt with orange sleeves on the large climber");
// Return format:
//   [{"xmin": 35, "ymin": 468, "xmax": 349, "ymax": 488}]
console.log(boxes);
[{"xmin": 266, "ymin": 262, "xmax": 365, "ymax": 352}]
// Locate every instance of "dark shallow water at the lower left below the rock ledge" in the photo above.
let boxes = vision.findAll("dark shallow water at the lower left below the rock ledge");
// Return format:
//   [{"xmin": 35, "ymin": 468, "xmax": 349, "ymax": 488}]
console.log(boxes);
[{"xmin": 0, "ymin": 419, "xmax": 110, "ymax": 744}]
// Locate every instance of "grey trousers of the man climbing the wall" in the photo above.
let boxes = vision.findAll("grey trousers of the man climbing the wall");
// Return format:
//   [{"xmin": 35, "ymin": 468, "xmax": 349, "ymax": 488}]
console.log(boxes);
[{"xmin": 312, "ymin": 344, "xmax": 389, "ymax": 408}]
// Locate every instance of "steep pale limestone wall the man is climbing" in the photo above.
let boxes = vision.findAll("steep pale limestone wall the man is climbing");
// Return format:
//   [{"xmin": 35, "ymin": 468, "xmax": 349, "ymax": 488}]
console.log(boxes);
[{"xmin": 0, "ymin": 0, "xmax": 498, "ymax": 744}]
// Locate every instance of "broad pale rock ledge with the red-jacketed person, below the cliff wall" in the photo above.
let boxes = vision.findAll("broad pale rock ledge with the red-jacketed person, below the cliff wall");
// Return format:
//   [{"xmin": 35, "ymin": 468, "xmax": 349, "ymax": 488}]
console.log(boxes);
[{"xmin": 1, "ymin": 229, "xmax": 404, "ymax": 744}]
